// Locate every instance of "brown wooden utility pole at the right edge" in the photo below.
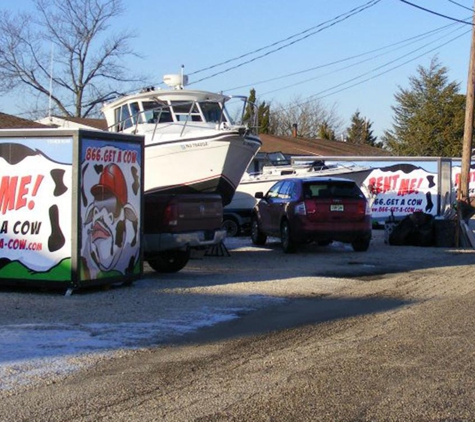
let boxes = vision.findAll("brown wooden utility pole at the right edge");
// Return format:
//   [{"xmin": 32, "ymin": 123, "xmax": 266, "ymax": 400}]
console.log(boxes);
[{"xmin": 457, "ymin": 1, "xmax": 475, "ymax": 206}]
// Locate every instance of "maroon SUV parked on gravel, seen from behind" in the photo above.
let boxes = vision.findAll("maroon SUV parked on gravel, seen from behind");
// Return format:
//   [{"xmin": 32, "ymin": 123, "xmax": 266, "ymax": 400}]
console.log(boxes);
[{"xmin": 251, "ymin": 177, "xmax": 371, "ymax": 253}]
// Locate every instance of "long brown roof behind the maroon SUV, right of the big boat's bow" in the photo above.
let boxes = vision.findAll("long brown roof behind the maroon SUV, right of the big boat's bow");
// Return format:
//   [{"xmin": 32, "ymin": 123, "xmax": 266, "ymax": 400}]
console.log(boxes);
[{"xmin": 259, "ymin": 134, "xmax": 391, "ymax": 157}]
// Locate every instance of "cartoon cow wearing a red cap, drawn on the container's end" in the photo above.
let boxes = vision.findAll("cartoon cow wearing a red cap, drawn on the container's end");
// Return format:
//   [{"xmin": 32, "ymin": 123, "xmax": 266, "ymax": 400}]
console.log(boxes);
[{"xmin": 82, "ymin": 164, "xmax": 138, "ymax": 276}]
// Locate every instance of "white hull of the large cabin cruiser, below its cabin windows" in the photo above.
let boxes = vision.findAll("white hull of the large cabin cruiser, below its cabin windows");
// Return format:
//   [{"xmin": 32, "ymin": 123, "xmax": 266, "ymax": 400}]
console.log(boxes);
[{"xmin": 144, "ymin": 131, "xmax": 261, "ymax": 205}]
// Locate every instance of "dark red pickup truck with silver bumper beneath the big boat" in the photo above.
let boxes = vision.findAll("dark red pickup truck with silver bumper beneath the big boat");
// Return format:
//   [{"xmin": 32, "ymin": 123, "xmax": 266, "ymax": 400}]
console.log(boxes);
[{"xmin": 143, "ymin": 193, "xmax": 226, "ymax": 273}]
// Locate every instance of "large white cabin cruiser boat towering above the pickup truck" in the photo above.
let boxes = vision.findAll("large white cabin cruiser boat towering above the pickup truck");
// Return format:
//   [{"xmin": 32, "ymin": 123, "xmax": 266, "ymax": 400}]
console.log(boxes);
[{"xmin": 102, "ymin": 75, "xmax": 262, "ymax": 205}]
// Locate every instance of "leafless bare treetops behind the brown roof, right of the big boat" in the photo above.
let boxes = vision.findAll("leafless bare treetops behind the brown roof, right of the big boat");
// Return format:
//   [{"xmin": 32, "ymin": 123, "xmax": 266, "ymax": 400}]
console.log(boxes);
[{"xmin": 270, "ymin": 99, "xmax": 342, "ymax": 139}]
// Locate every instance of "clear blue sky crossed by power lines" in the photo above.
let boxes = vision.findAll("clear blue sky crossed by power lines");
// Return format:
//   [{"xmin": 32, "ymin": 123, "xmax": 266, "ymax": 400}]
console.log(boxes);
[{"xmin": 0, "ymin": 0, "xmax": 473, "ymax": 136}]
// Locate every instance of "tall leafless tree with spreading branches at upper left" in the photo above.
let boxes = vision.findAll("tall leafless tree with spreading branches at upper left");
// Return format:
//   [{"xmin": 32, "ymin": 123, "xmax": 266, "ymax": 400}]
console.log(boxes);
[{"xmin": 0, "ymin": 0, "xmax": 141, "ymax": 117}]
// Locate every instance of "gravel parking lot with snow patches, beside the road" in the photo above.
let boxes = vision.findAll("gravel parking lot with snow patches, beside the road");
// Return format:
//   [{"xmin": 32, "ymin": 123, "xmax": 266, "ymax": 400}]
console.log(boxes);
[{"xmin": 0, "ymin": 230, "xmax": 474, "ymax": 392}]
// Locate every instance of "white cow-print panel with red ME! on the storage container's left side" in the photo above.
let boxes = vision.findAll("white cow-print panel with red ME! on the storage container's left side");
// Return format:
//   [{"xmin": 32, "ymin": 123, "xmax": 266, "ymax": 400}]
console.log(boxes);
[{"xmin": 0, "ymin": 137, "xmax": 73, "ymax": 281}]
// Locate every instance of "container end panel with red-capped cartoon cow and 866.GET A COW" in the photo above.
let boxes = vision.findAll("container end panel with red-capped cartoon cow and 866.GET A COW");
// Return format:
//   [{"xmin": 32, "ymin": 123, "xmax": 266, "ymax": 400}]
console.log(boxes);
[{"xmin": 79, "ymin": 139, "xmax": 142, "ymax": 279}]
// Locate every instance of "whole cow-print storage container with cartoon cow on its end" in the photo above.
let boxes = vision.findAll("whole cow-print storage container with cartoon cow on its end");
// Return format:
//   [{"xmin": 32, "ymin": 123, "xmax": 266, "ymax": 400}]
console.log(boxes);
[{"xmin": 0, "ymin": 129, "xmax": 144, "ymax": 292}]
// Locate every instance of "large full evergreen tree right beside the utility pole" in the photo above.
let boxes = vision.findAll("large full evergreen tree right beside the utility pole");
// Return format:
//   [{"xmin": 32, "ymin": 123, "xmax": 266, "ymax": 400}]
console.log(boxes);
[{"xmin": 382, "ymin": 58, "xmax": 465, "ymax": 157}]
